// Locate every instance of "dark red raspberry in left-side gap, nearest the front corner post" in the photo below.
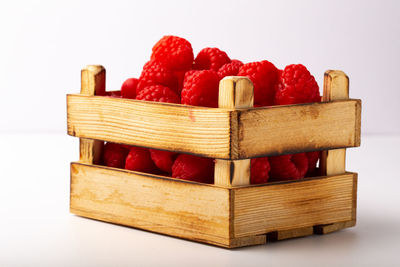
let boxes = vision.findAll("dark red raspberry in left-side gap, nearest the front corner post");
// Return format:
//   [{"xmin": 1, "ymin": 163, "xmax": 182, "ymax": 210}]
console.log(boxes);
[{"xmin": 172, "ymin": 154, "xmax": 214, "ymax": 183}]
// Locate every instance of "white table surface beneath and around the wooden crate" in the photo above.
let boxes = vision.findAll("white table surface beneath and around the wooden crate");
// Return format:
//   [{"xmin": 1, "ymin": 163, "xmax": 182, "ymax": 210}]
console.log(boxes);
[{"xmin": 0, "ymin": 134, "xmax": 400, "ymax": 266}]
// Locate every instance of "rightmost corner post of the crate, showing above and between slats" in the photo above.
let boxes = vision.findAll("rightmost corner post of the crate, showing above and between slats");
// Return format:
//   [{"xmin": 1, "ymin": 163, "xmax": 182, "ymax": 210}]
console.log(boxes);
[{"xmin": 320, "ymin": 70, "xmax": 350, "ymax": 175}]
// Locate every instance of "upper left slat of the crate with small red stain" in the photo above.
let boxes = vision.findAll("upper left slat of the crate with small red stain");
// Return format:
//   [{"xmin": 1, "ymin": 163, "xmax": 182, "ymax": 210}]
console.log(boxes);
[{"xmin": 67, "ymin": 95, "xmax": 230, "ymax": 158}]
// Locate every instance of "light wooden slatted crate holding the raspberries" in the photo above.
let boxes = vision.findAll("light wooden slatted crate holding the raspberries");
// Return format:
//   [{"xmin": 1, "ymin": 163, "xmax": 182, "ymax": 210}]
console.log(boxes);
[{"xmin": 67, "ymin": 66, "xmax": 361, "ymax": 248}]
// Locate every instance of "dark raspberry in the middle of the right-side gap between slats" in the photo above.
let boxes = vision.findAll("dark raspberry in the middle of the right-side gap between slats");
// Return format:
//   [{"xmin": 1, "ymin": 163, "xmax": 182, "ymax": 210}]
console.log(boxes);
[{"xmin": 269, "ymin": 153, "xmax": 308, "ymax": 181}]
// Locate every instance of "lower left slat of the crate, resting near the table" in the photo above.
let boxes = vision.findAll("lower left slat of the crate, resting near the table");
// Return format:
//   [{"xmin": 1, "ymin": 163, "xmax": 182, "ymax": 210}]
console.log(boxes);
[{"xmin": 70, "ymin": 163, "xmax": 233, "ymax": 247}]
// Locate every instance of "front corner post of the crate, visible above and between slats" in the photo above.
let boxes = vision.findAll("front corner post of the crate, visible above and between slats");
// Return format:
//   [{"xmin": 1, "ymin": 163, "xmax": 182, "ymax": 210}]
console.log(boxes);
[{"xmin": 214, "ymin": 76, "xmax": 254, "ymax": 186}]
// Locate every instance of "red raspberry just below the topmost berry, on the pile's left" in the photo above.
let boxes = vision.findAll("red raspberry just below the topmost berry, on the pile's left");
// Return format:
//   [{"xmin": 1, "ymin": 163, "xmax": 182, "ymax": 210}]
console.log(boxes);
[{"xmin": 136, "ymin": 60, "xmax": 178, "ymax": 95}]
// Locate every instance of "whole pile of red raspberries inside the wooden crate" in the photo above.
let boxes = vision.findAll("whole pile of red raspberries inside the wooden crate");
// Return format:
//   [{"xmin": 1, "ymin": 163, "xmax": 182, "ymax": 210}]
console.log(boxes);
[{"xmin": 103, "ymin": 36, "xmax": 321, "ymax": 184}]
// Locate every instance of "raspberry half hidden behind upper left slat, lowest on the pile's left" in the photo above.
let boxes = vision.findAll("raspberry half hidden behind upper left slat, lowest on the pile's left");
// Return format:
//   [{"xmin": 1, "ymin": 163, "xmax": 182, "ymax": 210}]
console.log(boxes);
[{"xmin": 136, "ymin": 85, "xmax": 180, "ymax": 103}]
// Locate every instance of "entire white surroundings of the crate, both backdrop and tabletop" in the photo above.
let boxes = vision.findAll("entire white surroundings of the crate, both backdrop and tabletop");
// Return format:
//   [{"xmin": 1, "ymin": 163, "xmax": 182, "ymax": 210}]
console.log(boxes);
[{"xmin": 0, "ymin": 0, "xmax": 400, "ymax": 267}]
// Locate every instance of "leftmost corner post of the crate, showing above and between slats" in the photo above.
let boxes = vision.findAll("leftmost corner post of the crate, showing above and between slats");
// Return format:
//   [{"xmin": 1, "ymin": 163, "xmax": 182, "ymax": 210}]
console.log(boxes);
[{"xmin": 79, "ymin": 65, "xmax": 106, "ymax": 164}]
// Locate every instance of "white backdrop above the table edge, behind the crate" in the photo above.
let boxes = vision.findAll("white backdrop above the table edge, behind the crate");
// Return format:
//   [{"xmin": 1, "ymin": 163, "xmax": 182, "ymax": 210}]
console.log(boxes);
[{"xmin": 0, "ymin": 0, "xmax": 400, "ymax": 134}]
